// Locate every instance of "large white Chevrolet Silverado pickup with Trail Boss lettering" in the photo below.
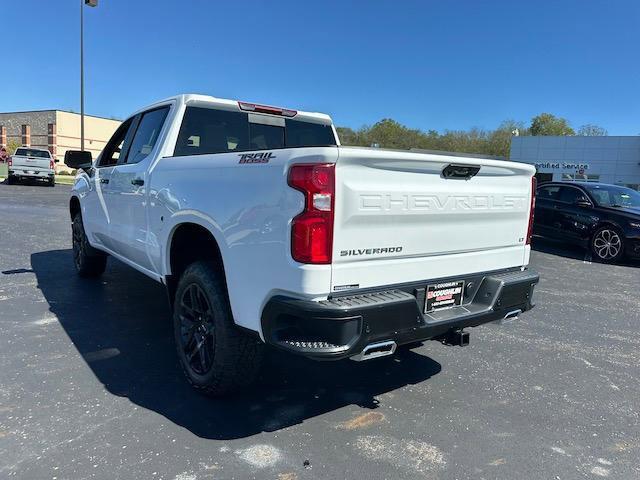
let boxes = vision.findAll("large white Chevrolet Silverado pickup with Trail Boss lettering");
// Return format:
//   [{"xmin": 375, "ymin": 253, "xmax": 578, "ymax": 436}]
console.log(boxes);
[{"xmin": 65, "ymin": 95, "xmax": 538, "ymax": 395}]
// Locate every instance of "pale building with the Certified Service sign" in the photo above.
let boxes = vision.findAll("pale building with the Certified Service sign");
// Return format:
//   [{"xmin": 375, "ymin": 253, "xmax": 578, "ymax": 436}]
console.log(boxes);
[{"xmin": 509, "ymin": 136, "xmax": 640, "ymax": 190}]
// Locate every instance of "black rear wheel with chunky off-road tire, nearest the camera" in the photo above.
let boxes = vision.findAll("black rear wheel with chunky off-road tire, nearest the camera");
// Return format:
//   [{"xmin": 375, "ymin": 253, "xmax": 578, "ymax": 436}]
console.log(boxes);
[{"xmin": 173, "ymin": 261, "xmax": 263, "ymax": 397}]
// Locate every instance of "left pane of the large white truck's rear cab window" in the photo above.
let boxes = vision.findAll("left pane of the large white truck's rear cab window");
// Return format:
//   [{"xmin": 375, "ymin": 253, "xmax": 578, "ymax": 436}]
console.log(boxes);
[{"xmin": 174, "ymin": 107, "xmax": 249, "ymax": 157}]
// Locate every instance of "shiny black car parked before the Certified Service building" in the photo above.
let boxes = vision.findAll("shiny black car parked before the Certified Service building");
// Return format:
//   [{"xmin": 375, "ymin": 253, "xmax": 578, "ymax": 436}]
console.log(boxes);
[{"xmin": 533, "ymin": 182, "xmax": 640, "ymax": 262}]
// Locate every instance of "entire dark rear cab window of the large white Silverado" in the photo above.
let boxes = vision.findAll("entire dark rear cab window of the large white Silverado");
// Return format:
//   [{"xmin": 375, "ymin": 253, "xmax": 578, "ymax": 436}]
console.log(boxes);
[{"xmin": 174, "ymin": 107, "xmax": 336, "ymax": 156}]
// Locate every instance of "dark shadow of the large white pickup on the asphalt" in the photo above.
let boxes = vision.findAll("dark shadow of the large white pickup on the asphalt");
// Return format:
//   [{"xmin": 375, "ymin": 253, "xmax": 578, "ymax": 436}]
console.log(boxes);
[{"xmin": 31, "ymin": 250, "xmax": 441, "ymax": 439}]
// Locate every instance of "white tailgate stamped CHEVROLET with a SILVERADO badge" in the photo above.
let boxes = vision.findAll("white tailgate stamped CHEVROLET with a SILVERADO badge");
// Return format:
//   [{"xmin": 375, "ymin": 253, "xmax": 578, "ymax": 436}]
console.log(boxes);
[{"xmin": 332, "ymin": 148, "xmax": 535, "ymax": 291}]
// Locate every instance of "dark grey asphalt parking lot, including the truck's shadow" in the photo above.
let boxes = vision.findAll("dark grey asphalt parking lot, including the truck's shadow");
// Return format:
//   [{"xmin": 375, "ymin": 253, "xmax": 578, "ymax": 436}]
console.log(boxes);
[{"xmin": 0, "ymin": 184, "xmax": 640, "ymax": 480}]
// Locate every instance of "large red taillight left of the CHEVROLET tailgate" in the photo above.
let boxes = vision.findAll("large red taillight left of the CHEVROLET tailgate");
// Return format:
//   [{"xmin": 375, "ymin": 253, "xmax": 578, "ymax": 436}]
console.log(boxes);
[{"xmin": 289, "ymin": 163, "xmax": 335, "ymax": 264}]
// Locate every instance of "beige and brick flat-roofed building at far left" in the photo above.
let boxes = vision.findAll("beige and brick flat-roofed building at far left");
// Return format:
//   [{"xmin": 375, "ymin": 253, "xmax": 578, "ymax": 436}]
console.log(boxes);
[{"xmin": 0, "ymin": 110, "xmax": 121, "ymax": 168}]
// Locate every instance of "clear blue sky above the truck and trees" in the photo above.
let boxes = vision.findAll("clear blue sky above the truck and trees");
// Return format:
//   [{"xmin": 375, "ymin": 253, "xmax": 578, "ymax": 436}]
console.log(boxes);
[{"xmin": 0, "ymin": 0, "xmax": 640, "ymax": 135}]
